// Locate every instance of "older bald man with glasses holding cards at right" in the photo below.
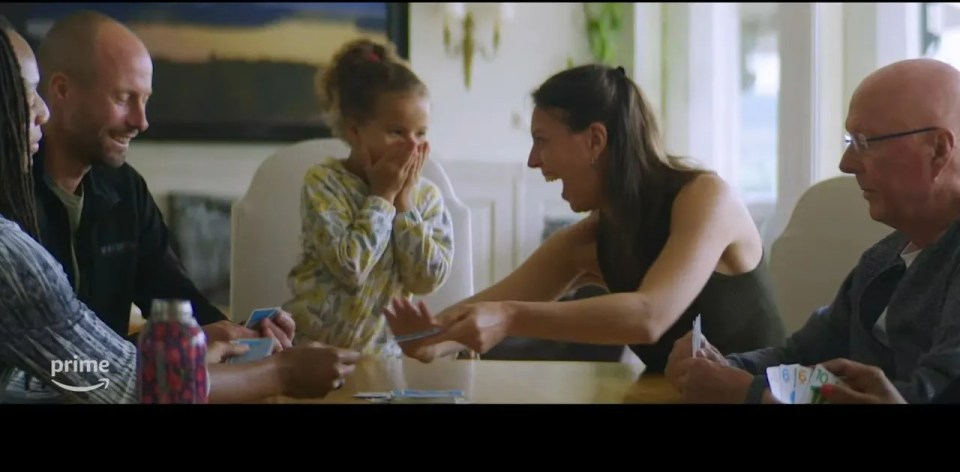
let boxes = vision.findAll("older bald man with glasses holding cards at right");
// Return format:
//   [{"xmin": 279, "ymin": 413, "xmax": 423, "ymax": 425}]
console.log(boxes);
[{"xmin": 667, "ymin": 59, "xmax": 960, "ymax": 403}]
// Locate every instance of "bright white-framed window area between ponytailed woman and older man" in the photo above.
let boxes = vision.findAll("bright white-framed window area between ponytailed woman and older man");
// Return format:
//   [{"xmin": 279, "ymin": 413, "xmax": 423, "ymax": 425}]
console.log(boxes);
[{"xmin": 663, "ymin": 3, "xmax": 824, "ymax": 244}]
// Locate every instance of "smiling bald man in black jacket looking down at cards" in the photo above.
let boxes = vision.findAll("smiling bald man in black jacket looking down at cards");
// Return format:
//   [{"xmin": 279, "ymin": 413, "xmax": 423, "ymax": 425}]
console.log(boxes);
[{"xmin": 34, "ymin": 12, "xmax": 294, "ymax": 349}]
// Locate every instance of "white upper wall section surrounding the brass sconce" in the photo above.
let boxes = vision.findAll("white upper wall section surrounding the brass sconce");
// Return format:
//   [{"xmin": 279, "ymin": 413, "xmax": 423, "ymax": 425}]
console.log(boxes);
[{"xmin": 410, "ymin": 3, "xmax": 590, "ymax": 162}]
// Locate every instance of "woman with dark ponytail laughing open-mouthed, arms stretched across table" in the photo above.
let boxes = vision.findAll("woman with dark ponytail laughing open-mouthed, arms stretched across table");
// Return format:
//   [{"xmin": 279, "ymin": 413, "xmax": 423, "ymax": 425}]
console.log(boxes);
[{"xmin": 387, "ymin": 65, "xmax": 785, "ymax": 372}]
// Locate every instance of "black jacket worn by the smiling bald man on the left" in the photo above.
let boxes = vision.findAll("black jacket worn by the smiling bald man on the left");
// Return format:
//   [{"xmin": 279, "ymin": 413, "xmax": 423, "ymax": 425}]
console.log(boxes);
[{"xmin": 33, "ymin": 150, "xmax": 227, "ymax": 337}]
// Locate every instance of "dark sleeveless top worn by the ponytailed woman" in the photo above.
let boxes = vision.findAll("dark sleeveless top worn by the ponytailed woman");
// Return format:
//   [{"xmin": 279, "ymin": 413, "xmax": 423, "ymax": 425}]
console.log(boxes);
[{"xmin": 597, "ymin": 199, "xmax": 786, "ymax": 373}]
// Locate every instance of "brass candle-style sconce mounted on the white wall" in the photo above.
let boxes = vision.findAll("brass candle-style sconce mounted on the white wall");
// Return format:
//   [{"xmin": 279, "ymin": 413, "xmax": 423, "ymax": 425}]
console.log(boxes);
[{"xmin": 443, "ymin": 3, "xmax": 514, "ymax": 90}]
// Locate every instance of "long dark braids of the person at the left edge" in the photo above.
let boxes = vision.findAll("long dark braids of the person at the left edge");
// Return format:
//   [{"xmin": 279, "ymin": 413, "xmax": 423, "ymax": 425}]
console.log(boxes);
[{"xmin": 0, "ymin": 17, "xmax": 40, "ymax": 240}]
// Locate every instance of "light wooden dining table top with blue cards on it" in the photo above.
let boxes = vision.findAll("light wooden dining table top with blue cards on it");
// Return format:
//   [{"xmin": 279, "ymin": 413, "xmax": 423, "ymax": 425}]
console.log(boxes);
[{"xmin": 268, "ymin": 358, "xmax": 680, "ymax": 404}]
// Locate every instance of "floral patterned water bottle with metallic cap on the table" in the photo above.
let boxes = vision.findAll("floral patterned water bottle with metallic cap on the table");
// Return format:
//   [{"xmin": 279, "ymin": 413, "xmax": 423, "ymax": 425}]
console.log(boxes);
[{"xmin": 137, "ymin": 300, "xmax": 210, "ymax": 403}]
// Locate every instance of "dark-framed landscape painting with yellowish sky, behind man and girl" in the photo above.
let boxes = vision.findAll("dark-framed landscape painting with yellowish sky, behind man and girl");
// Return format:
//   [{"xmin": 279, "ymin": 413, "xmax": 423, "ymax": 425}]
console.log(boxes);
[{"xmin": 0, "ymin": 2, "xmax": 409, "ymax": 142}]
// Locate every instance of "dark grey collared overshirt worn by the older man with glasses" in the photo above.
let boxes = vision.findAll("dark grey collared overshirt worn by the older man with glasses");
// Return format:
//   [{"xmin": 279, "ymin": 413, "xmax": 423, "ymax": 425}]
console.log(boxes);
[{"xmin": 727, "ymin": 221, "xmax": 960, "ymax": 403}]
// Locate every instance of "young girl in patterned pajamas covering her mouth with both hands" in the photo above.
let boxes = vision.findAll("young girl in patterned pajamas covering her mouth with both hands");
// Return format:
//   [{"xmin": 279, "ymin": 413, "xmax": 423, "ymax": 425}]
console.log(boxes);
[{"xmin": 283, "ymin": 39, "xmax": 453, "ymax": 357}]
